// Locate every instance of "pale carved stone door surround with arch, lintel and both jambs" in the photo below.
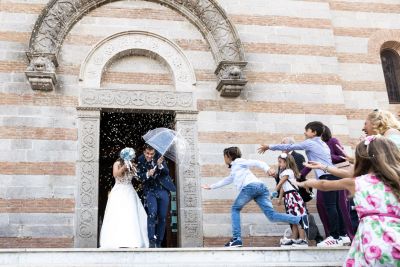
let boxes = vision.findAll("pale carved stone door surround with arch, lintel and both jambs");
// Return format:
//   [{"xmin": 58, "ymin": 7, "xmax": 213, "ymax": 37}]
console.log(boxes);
[{"xmin": 75, "ymin": 31, "xmax": 203, "ymax": 247}]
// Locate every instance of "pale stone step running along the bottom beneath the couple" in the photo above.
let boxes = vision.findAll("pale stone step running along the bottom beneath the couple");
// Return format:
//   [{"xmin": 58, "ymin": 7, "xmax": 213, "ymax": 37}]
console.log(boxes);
[{"xmin": 0, "ymin": 247, "xmax": 349, "ymax": 267}]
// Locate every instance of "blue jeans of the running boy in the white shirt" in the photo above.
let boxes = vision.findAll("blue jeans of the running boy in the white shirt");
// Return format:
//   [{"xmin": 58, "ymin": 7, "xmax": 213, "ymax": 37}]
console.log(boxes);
[{"xmin": 232, "ymin": 183, "xmax": 301, "ymax": 238}]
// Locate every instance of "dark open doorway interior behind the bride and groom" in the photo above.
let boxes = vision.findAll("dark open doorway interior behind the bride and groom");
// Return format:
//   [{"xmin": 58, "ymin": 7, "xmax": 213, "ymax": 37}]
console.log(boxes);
[{"xmin": 98, "ymin": 110, "xmax": 178, "ymax": 247}]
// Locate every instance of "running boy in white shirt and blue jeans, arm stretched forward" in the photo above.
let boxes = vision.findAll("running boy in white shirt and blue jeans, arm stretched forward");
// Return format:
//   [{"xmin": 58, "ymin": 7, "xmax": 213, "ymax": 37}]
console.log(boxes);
[{"xmin": 202, "ymin": 147, "xmax": 308, "ymax": 247}]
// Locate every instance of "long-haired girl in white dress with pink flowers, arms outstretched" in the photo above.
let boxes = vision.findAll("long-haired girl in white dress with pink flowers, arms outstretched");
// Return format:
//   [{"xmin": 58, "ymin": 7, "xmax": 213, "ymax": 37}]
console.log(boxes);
[{"xmin": 298, "ymin": 135, "xmax": 400, "ymax": 267}]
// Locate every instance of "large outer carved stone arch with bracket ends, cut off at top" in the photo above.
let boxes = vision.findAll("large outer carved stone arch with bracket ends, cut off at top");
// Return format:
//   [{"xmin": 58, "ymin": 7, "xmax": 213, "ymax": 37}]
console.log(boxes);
[{"xmin": 25, "ymin": 0, "xmax": 247, "ymax": 96}]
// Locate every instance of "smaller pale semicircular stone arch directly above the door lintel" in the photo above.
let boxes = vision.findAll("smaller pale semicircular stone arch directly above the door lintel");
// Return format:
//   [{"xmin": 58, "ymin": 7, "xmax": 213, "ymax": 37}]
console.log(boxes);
[{"xmin": 79, "ymin": 31, "xmax": 196, "ymax": 91}]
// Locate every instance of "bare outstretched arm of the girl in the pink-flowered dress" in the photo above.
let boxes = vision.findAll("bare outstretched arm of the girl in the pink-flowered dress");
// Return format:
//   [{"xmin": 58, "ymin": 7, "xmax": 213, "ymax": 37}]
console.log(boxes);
[{"xmin": 296, "ymin": 178, "xmax": 355, "ymax": 195}]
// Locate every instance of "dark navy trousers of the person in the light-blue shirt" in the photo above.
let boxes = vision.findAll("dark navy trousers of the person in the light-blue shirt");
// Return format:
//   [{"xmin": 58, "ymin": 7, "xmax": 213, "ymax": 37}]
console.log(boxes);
[{"xmin": 318, "ymin": 175, "xmax": 347, "ymax": 239}]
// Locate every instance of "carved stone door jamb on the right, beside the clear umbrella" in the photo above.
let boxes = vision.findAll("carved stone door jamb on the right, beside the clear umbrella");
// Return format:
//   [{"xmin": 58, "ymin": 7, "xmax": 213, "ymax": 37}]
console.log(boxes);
[{"xmin": 175, "ymin": 111, "xmax": 203, "ymax": 247}]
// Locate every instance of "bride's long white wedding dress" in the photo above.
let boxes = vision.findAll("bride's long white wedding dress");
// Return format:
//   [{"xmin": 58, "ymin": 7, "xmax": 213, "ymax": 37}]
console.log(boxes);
[{"xmin": 100, "ymin": 172, "xmax": 149, "ymax": 248}]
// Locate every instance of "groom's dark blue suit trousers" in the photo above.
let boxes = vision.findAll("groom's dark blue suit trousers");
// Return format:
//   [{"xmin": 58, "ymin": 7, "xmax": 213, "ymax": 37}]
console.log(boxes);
[{"xmin": 145, "ymin": 189, "xmax": 169, "ymax": 246}]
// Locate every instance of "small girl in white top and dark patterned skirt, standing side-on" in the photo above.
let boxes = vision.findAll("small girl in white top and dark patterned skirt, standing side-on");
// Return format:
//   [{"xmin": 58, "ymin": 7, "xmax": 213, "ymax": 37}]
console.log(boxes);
[{"xmin": 276, "ymin": 153, "xmax": 308, "ymax": 246}]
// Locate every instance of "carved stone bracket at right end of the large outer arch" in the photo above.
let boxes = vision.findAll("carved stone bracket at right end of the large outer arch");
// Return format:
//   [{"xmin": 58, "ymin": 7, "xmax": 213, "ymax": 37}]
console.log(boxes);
[{"xmin": 215, "ymin": 61, "xmax": 247, "ymax": 97}]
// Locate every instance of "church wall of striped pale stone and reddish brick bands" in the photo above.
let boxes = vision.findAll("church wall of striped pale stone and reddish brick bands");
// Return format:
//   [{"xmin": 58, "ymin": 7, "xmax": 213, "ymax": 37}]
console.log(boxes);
[{"xmin": 0, "ymin": 0, "xmax": 400, "ymax": 247}]
